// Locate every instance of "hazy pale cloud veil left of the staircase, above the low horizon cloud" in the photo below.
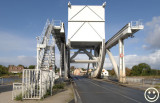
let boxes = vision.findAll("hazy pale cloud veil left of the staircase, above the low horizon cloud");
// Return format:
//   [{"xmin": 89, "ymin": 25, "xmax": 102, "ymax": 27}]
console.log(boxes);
[{"xmin": 0, "ymin": 31, "xmax": 36, "ymax": 54}]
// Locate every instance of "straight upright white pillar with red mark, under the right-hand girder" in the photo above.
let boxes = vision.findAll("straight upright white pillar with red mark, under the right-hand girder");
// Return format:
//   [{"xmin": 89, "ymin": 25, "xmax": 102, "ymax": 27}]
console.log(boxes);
[{"xmin": 119, "ymin": 39, "xmax": 126, "ymax": 83}]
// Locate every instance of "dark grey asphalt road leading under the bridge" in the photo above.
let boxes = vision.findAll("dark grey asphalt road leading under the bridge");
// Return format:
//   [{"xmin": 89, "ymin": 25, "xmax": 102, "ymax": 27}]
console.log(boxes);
[{"xmin": 73, "ymin": 77, "xmax": 160, "ymax": 103}]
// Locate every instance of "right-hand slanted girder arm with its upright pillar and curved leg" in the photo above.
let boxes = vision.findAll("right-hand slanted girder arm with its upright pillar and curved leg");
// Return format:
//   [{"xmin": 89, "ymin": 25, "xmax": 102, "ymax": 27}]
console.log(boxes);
[{"xmin": 105, "ymin": 21, "xmax": 144, "ymax": 83}]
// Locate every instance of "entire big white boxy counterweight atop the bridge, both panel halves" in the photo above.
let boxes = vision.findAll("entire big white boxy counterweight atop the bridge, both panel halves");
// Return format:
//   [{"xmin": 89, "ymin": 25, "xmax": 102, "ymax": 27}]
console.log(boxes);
[{"xmin": 68, "ymin": 5, "xmax": 105, "ymax": 46}]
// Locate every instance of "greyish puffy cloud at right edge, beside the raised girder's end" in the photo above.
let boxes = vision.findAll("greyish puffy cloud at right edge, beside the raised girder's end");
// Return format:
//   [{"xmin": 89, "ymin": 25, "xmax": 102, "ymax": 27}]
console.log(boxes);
[{"xmin": 145, "ymin": 16, "xmax": 160, "ymax": 49}]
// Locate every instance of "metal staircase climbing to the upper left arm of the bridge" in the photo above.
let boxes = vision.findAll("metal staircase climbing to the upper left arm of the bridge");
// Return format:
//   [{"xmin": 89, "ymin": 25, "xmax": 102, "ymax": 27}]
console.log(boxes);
[{"xmin": 37, "ymin": 20, "xmax": 55, "ymax": 70}]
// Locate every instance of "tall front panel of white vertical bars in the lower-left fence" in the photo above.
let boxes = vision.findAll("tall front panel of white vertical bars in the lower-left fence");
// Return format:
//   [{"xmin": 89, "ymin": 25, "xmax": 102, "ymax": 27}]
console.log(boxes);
[{"xmin": 22, "ymin": 69, "xmax": 42, "ymax": 99}]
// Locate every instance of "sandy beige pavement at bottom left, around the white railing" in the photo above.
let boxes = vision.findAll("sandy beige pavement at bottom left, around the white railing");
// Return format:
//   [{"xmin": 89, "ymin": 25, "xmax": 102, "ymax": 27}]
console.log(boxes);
[{"xmin": 0, "ymin": 85, "xmax": 74, "ymax": 103}]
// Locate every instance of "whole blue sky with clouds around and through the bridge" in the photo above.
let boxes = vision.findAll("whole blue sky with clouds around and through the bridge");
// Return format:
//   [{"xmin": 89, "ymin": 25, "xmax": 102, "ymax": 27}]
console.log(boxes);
[{"xmin": 0, "ymin": 0, "xmax": 160, "ymax": 69}]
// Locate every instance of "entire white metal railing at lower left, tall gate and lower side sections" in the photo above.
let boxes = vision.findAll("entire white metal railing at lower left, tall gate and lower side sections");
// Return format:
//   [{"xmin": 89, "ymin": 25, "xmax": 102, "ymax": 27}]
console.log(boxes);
[{"xmin": 12, "ymin": 69, "xmax": 55, "ymax": 99}]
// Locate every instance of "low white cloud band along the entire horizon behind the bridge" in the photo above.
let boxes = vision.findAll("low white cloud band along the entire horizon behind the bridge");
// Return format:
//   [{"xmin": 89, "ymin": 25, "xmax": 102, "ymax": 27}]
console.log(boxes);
[{"xmin": 0, "ymin": 50, "xmax": 160, "ymax": 69}]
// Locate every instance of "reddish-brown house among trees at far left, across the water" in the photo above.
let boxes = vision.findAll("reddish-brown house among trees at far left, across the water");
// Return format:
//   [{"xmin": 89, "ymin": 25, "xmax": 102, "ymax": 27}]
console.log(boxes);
[{"xmin": 8, "ymin": 65, "xmax": 24, "ymax": 73}]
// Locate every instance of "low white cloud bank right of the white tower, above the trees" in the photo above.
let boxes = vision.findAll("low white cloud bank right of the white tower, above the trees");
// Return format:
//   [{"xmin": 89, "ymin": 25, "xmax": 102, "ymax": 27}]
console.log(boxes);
[{"xmin": 104, "ymin": 50, "xmax": 160, "ymax": 69}]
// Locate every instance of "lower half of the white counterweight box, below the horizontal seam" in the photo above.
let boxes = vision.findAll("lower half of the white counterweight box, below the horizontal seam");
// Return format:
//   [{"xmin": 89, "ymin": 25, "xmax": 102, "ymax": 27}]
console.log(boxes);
[{"xmin": 68, "ymin": 22, "xmax": 105, "ymax": 42}]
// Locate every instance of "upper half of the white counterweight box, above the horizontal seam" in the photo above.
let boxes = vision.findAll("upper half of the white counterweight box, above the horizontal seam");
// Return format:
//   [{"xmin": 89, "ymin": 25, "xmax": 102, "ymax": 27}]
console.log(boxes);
[{"xmin": 68, "ymin": 6, "xmax": 105, "ymax": 21}]
